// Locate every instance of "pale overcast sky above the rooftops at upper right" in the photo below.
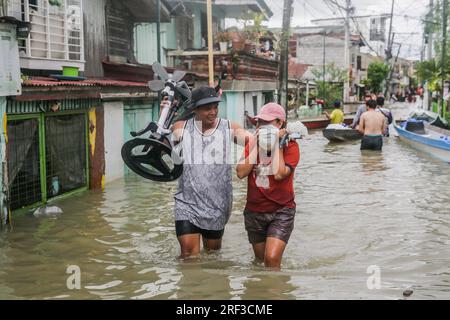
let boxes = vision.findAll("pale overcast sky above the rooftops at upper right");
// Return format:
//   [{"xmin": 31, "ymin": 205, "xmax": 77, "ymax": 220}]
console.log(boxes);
[{"xmin": 266, "ymin": 0, "xmax": 429, "ymax": 59}]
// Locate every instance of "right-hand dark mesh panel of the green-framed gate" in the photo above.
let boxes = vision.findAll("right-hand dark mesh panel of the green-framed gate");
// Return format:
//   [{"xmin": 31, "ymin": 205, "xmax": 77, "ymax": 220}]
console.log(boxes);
[{"xmin": 45, "ymin": 114, "xmax": 87, "ymax": 198}]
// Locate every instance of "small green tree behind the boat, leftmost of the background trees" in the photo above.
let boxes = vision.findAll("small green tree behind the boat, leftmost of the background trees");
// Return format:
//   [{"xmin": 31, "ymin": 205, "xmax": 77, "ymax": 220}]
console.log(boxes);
[{"xmin": 311, "ymin": 62, "xmax": 348, "ymax": 107}]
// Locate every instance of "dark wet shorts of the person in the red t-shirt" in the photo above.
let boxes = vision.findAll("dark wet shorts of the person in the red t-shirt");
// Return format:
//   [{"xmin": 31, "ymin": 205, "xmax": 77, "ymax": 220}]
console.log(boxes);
[{"xmin": 244, "ymin": 207, "xmax": 295, "ymax": 244}]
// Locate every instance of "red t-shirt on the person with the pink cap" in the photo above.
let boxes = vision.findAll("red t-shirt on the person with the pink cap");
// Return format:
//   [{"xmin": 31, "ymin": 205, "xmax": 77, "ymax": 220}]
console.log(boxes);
[{"xmin": 245, "ymin": 141, "xmax": 300, "ymax": 213}]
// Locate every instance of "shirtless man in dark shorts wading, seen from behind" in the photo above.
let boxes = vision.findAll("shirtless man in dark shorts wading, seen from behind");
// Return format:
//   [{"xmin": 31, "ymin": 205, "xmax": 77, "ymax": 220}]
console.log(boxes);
[{"xmin": 358, "ymin": 100, "xmax": 386, "ymax": 151}]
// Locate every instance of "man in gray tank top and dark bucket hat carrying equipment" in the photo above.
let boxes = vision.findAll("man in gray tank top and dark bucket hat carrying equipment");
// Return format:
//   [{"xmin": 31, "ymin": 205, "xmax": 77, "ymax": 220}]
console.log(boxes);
[{"xmin": 161, "ymin": 86, "xmax": 251, "ymax": 258}]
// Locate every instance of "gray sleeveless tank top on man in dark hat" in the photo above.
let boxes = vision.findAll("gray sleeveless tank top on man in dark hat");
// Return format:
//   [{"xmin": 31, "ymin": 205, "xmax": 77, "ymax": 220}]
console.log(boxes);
[{"xmin": 174, "ymin": 118, "xmax": 233, "ymax": 230}]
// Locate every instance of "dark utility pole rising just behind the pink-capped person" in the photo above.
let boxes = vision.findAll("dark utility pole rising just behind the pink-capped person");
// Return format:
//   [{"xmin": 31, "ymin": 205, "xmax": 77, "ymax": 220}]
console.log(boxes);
[{"xmin": 278, "ymin": 0, "xmax": 294, "ymax": 114}]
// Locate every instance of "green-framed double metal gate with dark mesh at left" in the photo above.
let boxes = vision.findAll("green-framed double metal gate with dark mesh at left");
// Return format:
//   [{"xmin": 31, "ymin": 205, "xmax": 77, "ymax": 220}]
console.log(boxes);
[{"xmin": 7, "ymin": 111, "xmax": 89, "ymax": 210}]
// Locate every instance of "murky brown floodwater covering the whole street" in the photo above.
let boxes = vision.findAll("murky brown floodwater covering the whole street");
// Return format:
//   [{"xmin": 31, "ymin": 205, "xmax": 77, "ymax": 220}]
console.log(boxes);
[{"xmin": 0, "ymin": 103, "xmax": 450, "ymax": 299}]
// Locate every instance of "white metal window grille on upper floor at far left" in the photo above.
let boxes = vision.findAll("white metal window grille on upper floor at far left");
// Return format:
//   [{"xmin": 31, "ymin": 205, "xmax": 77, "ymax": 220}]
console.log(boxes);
[{"xmin": 8, "ymin": 0, "xmax": 84, "ymax": 70}]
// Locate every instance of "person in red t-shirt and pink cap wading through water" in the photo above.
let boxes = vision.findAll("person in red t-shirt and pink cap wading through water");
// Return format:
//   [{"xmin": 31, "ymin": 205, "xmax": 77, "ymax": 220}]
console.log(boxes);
[{"xmin": 236, "ymin": 103, "xmax": 300, "ymax": 269}]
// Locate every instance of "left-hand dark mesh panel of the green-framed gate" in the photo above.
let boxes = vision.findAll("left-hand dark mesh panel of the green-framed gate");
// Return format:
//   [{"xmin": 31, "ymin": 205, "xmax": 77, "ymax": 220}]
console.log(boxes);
[{"xmin": 7, "ymin": 119, "xmax": 42, "ymax": 210}]
